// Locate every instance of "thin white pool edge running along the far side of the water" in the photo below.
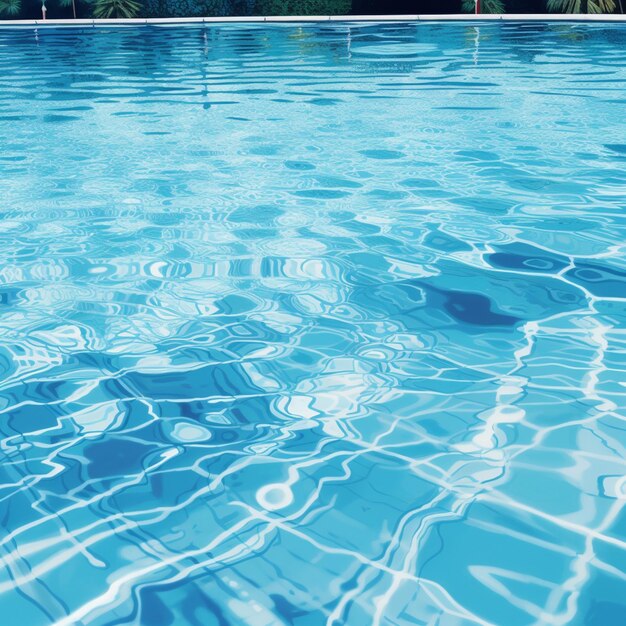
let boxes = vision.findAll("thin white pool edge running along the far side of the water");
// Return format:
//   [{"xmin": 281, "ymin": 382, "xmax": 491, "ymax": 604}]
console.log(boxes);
[{"xmin": 0, "ymin": 13, "xmax": 626, "ymax": 28}]
